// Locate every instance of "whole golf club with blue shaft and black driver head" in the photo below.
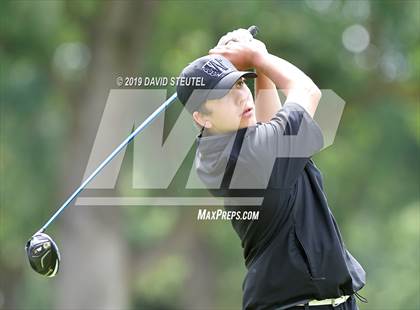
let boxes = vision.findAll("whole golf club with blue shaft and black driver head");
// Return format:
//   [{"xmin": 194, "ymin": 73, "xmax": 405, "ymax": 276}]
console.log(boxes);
[{"xmin": 25, "ymin": 26, "xmax": 258, "ymax": 277}]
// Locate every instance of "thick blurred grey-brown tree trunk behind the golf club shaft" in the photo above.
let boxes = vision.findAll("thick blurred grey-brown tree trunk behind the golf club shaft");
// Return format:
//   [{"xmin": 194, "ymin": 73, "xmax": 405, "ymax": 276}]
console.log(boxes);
[{"xmin": 55, "ymin": 1, "xmax": 155, "ymax": 309}]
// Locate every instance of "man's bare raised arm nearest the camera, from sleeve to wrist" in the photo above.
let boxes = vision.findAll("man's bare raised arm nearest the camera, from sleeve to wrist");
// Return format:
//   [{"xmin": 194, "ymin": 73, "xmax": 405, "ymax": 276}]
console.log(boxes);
[{"xmin": 254, "ymin": 53, "xmax": 321, "ymax": 116}]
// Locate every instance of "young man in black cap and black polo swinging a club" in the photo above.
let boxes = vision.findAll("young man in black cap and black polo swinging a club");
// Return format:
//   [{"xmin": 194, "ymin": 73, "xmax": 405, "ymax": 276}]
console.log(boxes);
[{"xmin": 177, "ymin": 29, "xmax": 365, "ymax": 310}]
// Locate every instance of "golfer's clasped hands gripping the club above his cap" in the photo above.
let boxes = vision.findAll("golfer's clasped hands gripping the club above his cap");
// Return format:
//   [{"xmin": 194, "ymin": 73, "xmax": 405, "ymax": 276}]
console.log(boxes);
[{"xmin": 209, "ymin": 29, "xmax": 268, "ymax": 70}]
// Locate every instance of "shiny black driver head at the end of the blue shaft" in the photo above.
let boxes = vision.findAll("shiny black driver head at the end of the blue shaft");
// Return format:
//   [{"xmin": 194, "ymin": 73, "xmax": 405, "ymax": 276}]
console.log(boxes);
[{"xmin": 25, "ymin": 232, "xmax": 60, "ymax": 277}]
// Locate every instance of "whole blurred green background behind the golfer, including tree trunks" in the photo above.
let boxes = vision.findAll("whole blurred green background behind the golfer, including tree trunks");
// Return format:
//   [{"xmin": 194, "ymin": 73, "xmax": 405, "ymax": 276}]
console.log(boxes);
[{"xmin": 0, "ymin": 0, "xmax": 420, "ymax": 310}]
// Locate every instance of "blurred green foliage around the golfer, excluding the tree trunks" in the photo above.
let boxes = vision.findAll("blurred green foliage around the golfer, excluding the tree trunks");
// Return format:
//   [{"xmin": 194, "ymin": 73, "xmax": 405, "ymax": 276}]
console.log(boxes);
[{"xmin": 0, "ymin": 0, "xmax": 420, "ymax": 310}]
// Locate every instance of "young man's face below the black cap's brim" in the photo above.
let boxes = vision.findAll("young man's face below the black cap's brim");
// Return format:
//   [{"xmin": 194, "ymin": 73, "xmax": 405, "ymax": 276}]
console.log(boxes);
[{"xmin": 201, "ymin": 78, "xmax": 257, "ymax": 133}]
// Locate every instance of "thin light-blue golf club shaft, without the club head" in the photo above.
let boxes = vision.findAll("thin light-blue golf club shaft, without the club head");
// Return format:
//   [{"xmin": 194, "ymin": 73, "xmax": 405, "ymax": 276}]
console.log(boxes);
[{"xmin": 38, "ymin": 26, "xmax": 258, "ymax": 232}]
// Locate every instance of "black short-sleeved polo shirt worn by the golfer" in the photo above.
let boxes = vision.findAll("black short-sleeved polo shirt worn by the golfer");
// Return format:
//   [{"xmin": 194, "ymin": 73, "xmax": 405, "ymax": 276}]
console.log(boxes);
[{"xmin": 195, "ymin": 102, "xmax": 365, "ymax": 309}]
